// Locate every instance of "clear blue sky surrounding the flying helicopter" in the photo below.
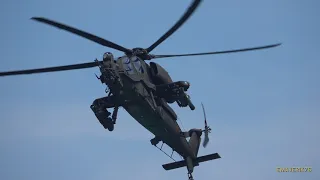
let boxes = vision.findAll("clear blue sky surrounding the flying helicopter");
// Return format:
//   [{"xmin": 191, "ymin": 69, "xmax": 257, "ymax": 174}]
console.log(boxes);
[{"xmin": 0, "ymin": 0, "xmax": 320, "ymax": 180}]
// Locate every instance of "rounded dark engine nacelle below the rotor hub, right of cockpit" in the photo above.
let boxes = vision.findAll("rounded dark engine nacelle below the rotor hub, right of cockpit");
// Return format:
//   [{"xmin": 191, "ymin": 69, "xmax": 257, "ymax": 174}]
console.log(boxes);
[{"xmin": 150, "ymin": 62, "xmax": 173, "ymax": 85}]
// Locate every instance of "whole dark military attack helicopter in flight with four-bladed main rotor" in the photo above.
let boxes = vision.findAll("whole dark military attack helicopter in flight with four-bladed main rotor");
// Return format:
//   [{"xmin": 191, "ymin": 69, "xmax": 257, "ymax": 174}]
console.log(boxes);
[{"xmin": 0, "ymin": 0, "xmax": 280, "ymax": 180}]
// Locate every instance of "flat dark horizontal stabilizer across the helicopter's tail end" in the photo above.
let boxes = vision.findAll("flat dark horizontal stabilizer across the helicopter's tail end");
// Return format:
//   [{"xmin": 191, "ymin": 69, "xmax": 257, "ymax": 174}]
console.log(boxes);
[{"xmin": 162, "ymin": 153, "xmax": 221, "ymax": 171}]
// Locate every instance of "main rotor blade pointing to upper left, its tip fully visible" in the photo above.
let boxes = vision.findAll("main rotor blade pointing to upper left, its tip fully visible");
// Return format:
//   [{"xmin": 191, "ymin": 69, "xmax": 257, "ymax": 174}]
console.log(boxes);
[{"xmin": 31, "ymin": 17, "xmax": 131, "ymax": 53}]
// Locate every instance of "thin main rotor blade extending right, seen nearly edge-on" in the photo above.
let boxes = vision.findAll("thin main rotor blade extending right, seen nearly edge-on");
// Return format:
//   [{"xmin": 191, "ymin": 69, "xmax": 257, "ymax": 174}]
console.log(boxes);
[{"xmin": 152, "ymin": 43, "xmax": 281, "ymax": 59}]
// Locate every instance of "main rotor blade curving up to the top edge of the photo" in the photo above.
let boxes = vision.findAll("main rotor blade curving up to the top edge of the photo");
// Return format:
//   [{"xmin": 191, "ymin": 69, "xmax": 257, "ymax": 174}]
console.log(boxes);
[{"xmin": 146, "ymin": 0, "xmax": 202, "ymax": 52}]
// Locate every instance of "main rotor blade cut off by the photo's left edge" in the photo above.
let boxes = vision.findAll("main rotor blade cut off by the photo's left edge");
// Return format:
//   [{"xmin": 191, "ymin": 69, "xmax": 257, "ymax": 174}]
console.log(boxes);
[{"xmin": 0, "ymin": 62, "xmax": 99, "ymax": 76}]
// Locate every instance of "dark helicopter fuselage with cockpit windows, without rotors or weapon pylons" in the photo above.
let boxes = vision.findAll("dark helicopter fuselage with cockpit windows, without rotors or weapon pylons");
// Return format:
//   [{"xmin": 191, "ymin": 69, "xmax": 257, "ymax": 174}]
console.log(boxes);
[{"xmin": 93, "ymin": 56, "xmax": 196, "ymax": 158}]
